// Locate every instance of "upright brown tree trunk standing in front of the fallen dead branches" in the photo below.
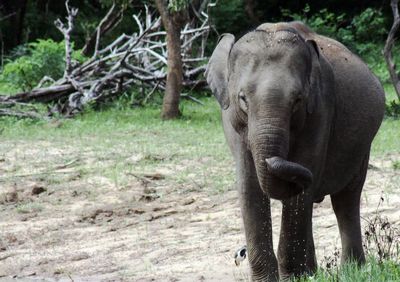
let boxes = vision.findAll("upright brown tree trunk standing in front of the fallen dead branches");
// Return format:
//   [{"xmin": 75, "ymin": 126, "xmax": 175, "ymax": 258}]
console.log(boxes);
[{"xmin": 155, "ymin": 0, "xmax": 187, "ymax": 119}]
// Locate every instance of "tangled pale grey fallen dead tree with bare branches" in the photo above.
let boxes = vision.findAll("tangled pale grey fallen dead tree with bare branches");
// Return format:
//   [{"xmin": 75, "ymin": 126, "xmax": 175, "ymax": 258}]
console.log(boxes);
[{"xmin": 0, "ymin": 1, "xmax": 209, "ymax": 116}]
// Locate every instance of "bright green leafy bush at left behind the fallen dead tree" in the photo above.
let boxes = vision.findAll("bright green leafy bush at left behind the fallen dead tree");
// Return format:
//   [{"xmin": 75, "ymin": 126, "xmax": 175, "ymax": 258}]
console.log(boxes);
[{"xmin": 0, "ymin": 39, "xmax": 84, "ymax": 91}]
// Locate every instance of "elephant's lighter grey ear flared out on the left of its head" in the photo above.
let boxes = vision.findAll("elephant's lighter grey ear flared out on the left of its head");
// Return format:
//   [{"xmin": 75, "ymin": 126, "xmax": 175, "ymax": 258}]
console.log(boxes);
[{"xmin": 205, "ymin": 33, "xmax": 235, "ymax": 110}]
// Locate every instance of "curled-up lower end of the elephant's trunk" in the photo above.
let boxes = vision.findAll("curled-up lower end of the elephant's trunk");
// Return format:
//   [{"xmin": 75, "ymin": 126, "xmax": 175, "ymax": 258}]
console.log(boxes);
[{"xmin": 261, "ymin": 157, "xmax": 313, "ymax": 200}]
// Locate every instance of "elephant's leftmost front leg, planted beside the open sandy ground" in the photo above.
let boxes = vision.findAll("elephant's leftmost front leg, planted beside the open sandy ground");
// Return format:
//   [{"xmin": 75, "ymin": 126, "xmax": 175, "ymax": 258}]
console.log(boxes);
[{"xmin": 237, "ymin": 149, "xmax": 279, "ymax": 281}]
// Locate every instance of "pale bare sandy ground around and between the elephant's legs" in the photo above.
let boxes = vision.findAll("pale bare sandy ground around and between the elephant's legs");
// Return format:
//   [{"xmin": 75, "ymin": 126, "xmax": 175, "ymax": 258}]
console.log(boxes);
[{"xmin": 0, "ymin": 142, "xmax": 400, "ymax": 281}]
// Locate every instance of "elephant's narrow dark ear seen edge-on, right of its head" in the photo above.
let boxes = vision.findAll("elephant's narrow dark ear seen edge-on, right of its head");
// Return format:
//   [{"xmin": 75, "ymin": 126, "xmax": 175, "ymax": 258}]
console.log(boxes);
[{"xmin": 306, "ymin": 39, "xmax": 321, "ymax": 114}]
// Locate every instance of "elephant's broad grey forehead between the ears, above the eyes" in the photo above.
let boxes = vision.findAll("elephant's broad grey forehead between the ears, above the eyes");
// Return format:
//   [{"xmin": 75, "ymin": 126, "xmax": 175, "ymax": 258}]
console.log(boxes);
[{"xmin": 229, "ymin": 33, "xmax": 311, "ymax": 91}]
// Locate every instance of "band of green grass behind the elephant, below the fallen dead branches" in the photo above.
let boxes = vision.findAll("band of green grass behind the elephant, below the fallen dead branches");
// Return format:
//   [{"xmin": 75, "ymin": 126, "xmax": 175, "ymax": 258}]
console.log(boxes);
[{"xmin": 0, "ymin": 94, "xmax": 400, "ymax": 156}]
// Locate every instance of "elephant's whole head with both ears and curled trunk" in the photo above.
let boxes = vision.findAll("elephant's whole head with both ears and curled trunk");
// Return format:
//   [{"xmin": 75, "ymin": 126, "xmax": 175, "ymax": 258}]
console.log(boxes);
[{"xmin": 206, "ymin": 28, "xmax": 320, "ymax": 200}]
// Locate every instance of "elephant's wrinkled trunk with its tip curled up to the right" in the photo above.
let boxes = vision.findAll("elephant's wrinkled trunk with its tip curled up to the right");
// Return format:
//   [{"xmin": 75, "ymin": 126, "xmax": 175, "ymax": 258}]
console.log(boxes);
[{"xmin": 249, "ymin": 118, "xmax": 313, "ymax": 200}]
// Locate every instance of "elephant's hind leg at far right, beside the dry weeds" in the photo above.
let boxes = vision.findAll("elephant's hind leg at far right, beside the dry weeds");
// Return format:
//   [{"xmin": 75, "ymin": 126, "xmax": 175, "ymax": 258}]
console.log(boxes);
[{"xmin": 331, "ymin": 155, "xmax": 369, "ymax": 263}]
